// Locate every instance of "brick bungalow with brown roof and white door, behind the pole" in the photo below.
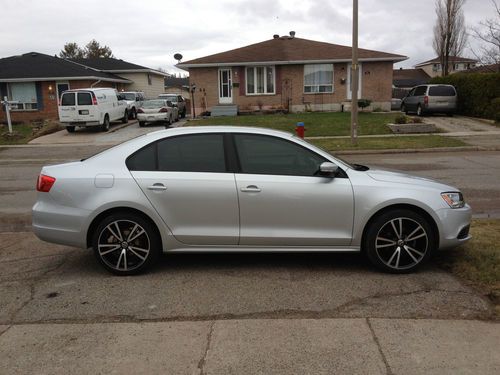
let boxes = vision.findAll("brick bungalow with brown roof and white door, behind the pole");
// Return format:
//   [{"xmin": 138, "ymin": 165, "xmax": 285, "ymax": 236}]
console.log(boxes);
[{"xmin": 177, "ymin": 32, "xmax": 407, "ymax": 114}]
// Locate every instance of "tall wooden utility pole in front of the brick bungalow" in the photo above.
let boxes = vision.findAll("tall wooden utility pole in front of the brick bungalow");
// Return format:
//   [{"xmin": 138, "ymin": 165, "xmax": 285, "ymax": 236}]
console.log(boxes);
[{"xmin": 351, "ymin": 0, "xmax": 359, "ymax": 145}]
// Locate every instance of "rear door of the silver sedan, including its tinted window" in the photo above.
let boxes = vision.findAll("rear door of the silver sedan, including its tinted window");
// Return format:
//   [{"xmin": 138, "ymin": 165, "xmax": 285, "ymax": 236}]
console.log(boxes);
[{"xmin": 127, "ymin": 133, "xmax": 239, "ymax": 245}]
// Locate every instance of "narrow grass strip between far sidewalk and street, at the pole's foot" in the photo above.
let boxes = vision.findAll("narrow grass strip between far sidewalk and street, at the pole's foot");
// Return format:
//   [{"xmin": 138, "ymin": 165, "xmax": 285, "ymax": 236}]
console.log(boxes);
[{"xmin": 308, "ymin": 135, "xmax": 467, "ymax": 152}]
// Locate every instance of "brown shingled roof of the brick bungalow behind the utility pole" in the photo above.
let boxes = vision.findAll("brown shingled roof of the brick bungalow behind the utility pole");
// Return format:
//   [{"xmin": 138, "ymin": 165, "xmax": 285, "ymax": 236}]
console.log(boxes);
[{"xmin": 177, "ymin": 36, "xmax": 408, "ymax": 68}]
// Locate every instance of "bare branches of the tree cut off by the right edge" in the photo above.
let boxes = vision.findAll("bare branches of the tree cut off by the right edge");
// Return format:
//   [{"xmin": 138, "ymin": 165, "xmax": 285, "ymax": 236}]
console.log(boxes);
[{"xmin": 471, "ymin": 0, "xmax": 500, "ymax": 71}]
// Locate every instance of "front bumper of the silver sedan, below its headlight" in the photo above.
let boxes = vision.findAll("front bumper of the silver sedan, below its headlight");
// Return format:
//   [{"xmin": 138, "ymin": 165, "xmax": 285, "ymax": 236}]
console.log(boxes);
[{"xmin": 436, "ymin": 204, "xmax": 472, "ymax": 250}]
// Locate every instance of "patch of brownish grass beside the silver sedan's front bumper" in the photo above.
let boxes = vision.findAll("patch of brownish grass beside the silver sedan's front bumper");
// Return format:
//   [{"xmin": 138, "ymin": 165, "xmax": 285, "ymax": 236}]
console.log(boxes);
[{"xmin": 436, "ymin": 219, "xmax": 500, "ymax": 317}]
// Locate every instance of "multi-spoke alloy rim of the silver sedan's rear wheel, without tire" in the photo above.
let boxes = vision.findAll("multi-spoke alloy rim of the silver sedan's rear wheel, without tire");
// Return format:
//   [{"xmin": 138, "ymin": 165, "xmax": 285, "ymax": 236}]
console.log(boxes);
[{"xmin": 97, "ymin": 220, "xmax": 151, "ymax": 271}]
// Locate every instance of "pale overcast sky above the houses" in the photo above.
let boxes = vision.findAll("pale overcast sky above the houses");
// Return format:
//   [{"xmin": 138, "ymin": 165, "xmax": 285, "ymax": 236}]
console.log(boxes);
[{"xmin": 0, "ymin": 0, "xmax": 493, "ymax": 73}]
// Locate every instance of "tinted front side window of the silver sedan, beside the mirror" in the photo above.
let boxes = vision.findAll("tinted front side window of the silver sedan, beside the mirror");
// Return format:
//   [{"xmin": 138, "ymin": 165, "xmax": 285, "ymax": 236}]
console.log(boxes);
[{"xmin": 234, "ymin": 134, "xmax": 326, "ymax": 176}]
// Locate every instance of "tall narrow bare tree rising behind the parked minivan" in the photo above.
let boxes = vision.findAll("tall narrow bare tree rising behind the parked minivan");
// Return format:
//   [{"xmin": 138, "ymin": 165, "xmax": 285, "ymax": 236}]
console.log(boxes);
[{"xmin": 433, "ymin": 0, "xmax": 467, "ymax": 76}]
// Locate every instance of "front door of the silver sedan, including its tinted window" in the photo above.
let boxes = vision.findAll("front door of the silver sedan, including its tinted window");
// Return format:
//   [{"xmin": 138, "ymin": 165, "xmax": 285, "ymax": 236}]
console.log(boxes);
[{"xmin": 234, "ymin": 133, "xmax": 354, "ymax": 246}]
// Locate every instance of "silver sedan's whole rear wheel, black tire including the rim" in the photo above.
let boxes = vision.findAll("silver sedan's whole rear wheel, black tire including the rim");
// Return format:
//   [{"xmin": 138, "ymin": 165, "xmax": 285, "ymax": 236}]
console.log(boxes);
[{"xmin": 92, "ymin": 212, "xmax": 161, "ymax": 276}]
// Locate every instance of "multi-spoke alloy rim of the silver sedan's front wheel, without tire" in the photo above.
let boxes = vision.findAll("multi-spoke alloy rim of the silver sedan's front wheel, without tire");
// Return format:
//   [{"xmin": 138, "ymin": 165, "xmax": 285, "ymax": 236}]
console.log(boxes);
[{"xmin": 375, "ymin": 217, "xmax": 429, "ymax": 270}]
